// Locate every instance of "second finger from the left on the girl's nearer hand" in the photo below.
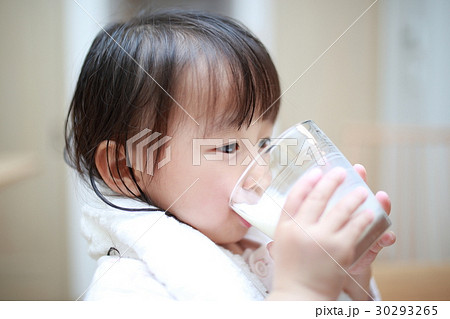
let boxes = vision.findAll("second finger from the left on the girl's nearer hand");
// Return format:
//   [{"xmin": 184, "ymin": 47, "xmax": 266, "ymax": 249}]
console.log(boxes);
[{"xmin": 296, "ymin": 167, "xmax": 347, "ymax": 223}]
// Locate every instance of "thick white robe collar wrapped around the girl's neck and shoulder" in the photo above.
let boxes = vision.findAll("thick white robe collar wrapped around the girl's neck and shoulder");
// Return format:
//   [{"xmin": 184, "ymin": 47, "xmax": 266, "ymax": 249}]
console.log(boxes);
[{"xmin": 82, "ymin": 197, "xmax": 267, "ymax": 300}]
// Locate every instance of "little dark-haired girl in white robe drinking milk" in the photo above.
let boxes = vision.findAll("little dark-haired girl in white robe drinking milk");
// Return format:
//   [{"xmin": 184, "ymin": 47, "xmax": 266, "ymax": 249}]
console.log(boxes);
[{"xmin": 66, "ymin": 11, "xmax": 395, "ymax": 300}]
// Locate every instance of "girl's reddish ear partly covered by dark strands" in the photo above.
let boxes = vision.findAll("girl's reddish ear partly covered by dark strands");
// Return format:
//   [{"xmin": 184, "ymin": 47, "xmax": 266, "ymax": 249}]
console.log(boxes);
[{"xmin": 95, "ymin": 140, "xmax": 140, "ymax": 197}]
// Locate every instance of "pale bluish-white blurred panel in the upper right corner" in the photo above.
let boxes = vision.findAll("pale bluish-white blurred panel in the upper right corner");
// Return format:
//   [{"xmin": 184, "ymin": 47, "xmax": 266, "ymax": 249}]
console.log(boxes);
[{"xmin": 379, "ymin": 0, "xmax": 450, "ymax": 125}]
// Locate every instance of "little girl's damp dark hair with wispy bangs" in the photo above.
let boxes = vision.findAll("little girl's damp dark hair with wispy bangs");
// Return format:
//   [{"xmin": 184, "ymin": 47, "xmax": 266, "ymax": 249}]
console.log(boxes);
[{"xmin": 65, "ymin": 10, "xmax": 280, "ymax": 204}]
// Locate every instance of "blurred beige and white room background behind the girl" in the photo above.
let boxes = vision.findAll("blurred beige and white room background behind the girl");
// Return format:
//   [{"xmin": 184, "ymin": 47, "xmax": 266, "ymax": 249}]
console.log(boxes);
[{"xmin": 0, "ymin": 0, "xmax": 450, "ymax": 300}]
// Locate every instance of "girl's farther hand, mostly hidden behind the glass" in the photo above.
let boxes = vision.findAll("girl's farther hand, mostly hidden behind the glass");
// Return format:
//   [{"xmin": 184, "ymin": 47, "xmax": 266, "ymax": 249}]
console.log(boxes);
[{"xmin": 344, "ymin": 164, "xmax": 396, "ymax": 300}]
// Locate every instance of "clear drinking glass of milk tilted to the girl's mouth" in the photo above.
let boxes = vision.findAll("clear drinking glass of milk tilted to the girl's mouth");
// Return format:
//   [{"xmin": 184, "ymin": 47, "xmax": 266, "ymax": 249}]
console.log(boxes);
[{"xmin": 230, "ymin": 121, "xmax": 391, "ymax": 261}]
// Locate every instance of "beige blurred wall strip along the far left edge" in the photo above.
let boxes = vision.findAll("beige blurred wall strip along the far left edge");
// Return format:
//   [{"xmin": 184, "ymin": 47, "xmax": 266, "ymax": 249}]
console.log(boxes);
[{"xmin": 0, "ymin": 0, "xmax": 67, "ymax": 300}]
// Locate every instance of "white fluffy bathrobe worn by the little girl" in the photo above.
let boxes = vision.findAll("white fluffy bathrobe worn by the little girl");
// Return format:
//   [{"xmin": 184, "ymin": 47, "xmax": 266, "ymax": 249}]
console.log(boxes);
[{"xmin": 81, "ymin": 197, "xmax": 381, "ymax": 301}]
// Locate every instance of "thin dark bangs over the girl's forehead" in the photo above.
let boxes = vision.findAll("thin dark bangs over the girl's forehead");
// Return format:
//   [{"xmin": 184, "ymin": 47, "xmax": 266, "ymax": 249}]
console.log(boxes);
[{"xmin": 171, "ymin": 20, "xmax": 281, "ymax": 134}]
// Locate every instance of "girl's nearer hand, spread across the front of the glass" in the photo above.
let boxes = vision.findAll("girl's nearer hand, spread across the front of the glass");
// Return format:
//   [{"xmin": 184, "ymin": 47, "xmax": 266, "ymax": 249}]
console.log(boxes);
[{"xmin": 268, "ymin": 168, "xmax": 373, "ymax": 300}]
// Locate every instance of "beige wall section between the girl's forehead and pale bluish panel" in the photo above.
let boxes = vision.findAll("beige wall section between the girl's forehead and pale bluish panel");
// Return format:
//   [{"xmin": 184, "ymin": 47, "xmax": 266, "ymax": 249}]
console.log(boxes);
[{"xmin": 274, "ymin": 0, "xmax": 378, "ymax": 147}]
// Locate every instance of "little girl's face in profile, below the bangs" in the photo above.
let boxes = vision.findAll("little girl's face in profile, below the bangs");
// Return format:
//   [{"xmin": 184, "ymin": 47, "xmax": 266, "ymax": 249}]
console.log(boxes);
[{"xmin": 144, "ymin": 119, "xmax": 273, "ymax": 244}]
